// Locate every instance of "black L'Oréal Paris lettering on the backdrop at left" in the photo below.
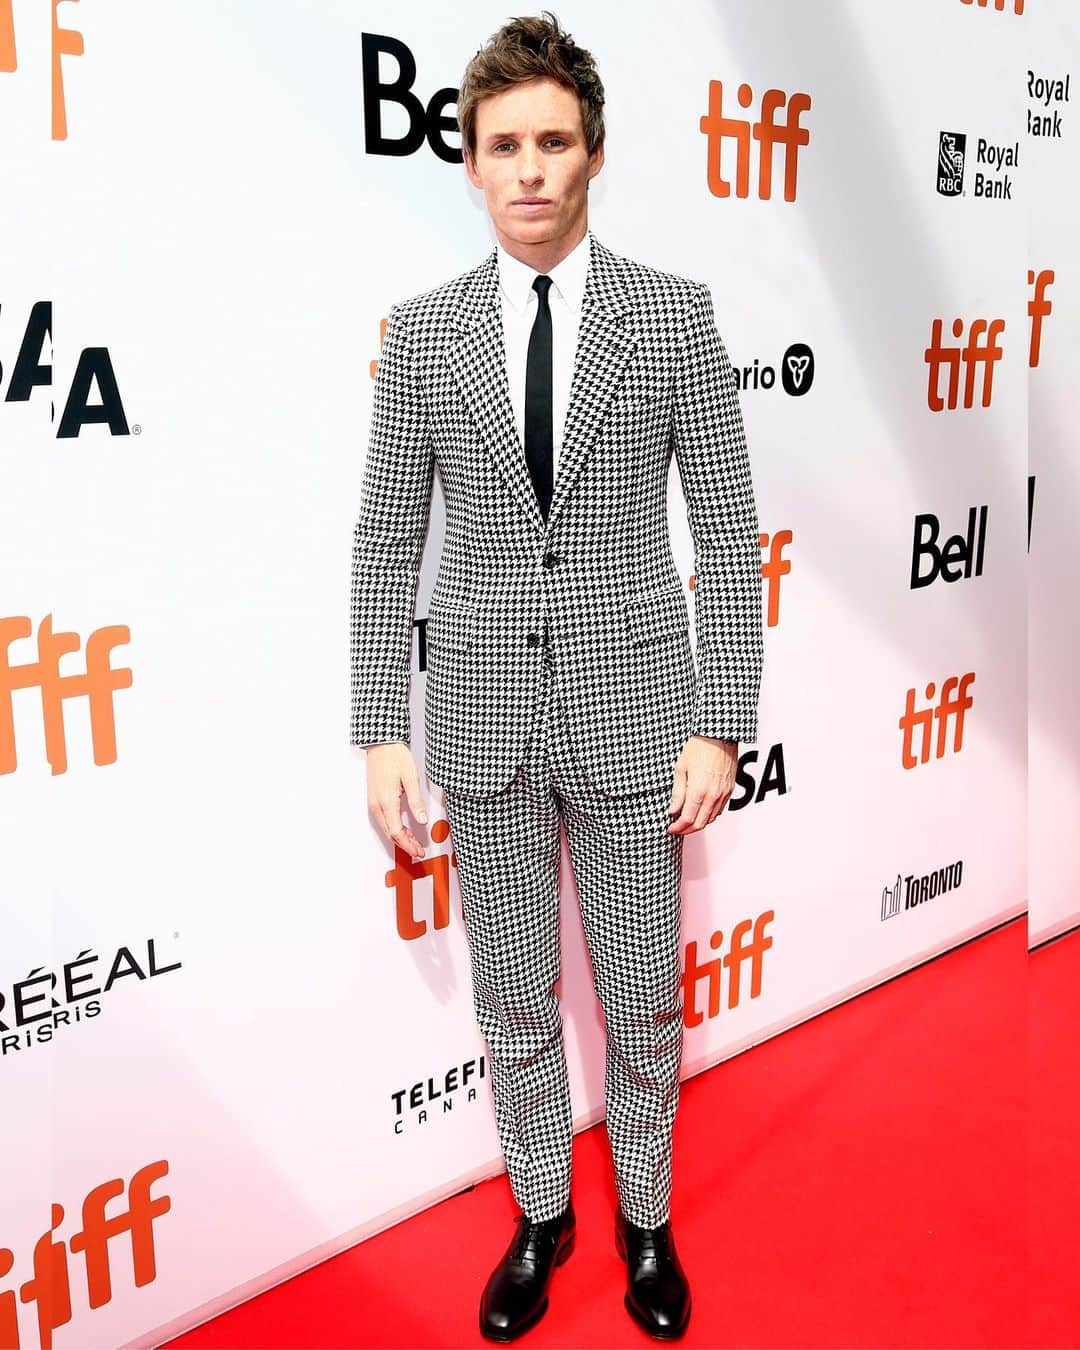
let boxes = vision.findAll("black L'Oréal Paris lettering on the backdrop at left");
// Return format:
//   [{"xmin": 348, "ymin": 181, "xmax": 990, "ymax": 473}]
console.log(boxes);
[{"xmin": 0, "ymin": 937, "xmax": 182, "ymax": 1058}]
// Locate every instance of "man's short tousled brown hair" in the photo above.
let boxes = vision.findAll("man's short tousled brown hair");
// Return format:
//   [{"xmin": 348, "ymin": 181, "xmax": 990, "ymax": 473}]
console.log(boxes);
[{"xmin": 458, "ymin": 9, "xmax": 603, "ymax": 158}]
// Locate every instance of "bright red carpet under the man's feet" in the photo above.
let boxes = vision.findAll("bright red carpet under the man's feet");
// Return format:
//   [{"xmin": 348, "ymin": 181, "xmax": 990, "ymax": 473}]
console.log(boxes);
[{"xmin": 169, "ymin": 919, "xmax": 1080, "ymax": 1350}]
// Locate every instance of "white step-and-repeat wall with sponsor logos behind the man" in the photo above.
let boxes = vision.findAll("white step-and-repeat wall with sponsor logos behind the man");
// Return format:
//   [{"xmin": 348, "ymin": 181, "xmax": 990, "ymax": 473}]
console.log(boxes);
[{"xmin": 0, "ymin": 0, "xmax": 1080, "ymax": 1347}]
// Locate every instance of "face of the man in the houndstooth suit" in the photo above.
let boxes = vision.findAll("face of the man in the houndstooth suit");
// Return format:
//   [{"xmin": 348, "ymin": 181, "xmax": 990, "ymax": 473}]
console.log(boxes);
[{"xmin": 464, "ymin": 76, "xmax": 603, "ymax": 247}]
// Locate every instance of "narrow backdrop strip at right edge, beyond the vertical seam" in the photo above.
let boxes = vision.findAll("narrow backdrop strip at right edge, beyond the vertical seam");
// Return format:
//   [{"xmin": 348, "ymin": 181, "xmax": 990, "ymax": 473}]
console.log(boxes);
[{"xmin": 1025, "ymin": 5, "xmax": 1080, "ymax": 946}]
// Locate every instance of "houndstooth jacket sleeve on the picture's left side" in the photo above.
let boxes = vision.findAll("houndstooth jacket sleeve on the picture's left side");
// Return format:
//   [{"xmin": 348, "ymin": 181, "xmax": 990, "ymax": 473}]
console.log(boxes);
[{"xmin": 350, "ymin": 305, "xmax": 435, "ymax": 745}]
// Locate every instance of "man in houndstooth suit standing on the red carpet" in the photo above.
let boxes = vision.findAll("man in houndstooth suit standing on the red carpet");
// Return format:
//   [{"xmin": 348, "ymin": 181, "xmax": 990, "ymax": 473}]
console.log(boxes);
[{"xmin": 351, "ymin": 11, "xmax": 763, "ymax": 1341}]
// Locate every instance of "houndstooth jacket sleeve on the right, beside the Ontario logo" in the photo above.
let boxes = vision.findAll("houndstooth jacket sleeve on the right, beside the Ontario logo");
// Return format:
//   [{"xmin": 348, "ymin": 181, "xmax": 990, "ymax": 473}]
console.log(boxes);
[{"xmin": 672, "ymin": 282, "xmax": 764, "ymax": 741}]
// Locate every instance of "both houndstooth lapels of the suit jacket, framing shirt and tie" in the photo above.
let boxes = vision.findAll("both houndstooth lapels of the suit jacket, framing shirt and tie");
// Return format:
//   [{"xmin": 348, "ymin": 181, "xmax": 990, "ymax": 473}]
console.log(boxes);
[{"xmin": 446, "ymin": 231, "xmax": 639, "ymax": 529}]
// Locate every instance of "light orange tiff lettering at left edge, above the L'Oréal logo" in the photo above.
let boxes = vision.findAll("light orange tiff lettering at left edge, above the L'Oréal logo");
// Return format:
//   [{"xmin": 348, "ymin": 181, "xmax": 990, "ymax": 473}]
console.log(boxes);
[{"xmin": 0, "ymin": 614, "xmax": 132, "ymax": 777}]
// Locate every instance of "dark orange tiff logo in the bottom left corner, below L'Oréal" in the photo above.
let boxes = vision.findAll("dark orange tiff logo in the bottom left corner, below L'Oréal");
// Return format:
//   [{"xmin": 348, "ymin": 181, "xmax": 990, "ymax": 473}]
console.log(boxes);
[{"xmin": 0, "ymin": 1158, "xmax": 173, "ymax": 1350}]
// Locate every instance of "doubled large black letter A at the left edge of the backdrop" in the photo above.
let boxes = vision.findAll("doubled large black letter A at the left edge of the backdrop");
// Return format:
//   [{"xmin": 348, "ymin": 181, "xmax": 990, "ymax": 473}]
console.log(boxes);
[{"xmin": 0, "ymin": 300, "xmax": 135, "ymax": 440}]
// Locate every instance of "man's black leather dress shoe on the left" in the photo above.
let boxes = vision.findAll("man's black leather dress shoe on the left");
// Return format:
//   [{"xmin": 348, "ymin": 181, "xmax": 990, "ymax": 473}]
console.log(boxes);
[{"xmin": 481, "ymin": 1206, "xmax": 575, "ymax": 1341}]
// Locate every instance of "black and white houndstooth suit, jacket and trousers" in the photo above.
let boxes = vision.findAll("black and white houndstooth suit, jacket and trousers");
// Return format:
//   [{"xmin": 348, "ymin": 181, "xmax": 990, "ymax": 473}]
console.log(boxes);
[{"xmin": 351, "ymin": 232, "xmax": 763, "ymax": 1226}]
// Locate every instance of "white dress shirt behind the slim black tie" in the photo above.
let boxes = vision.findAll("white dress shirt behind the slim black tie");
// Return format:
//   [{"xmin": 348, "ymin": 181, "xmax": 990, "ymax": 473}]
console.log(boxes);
[{"xmin": 495, "ymin": 230, "xmax": 589, "ymax": 483}]
